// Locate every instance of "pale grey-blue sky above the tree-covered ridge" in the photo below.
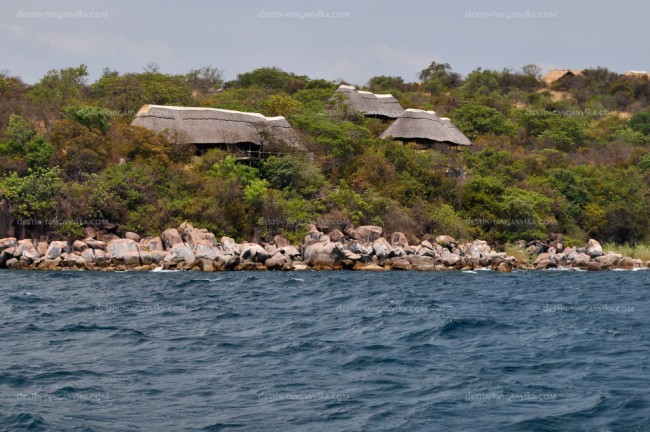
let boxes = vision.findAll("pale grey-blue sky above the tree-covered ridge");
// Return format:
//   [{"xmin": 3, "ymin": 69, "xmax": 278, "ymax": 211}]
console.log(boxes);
[{"xmin": 0, "ymin": 0, "xmax": 650, "ymax": 84}]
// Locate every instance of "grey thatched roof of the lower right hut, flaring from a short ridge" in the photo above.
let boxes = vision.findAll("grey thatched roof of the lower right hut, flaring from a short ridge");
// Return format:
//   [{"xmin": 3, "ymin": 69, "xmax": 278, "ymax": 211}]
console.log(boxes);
[{"xmin": 380, "ymin": 108, "xmax": 472, "ymax": 146}]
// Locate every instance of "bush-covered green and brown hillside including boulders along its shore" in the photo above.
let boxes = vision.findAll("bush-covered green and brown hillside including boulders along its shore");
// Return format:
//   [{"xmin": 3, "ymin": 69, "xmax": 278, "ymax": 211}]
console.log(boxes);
[{"xmin": 0, "ymin": 62, "xmax": 650, "ymax": 262}]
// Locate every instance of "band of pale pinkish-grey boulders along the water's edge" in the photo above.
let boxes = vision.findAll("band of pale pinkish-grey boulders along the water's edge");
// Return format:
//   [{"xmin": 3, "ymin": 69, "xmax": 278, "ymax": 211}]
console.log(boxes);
[{"xmin": 0, "ymin": 222, "xmax": 650, "ymax": 273}]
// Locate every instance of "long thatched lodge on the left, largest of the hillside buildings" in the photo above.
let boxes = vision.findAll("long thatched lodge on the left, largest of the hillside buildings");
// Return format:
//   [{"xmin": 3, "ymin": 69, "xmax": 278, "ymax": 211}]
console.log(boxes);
[{"xmin": 131, "ymin": 105, "xmax": 302, "ymax": 159}]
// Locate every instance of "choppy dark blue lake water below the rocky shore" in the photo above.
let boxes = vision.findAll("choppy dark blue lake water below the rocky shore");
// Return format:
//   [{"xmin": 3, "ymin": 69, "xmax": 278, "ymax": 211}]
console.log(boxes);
[{"xmin": 0, "ymin": 271, "xmax": 650, "ymax": 432}]
